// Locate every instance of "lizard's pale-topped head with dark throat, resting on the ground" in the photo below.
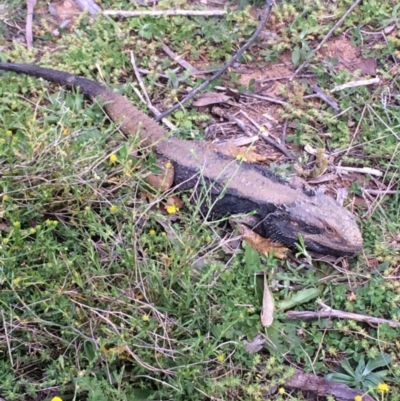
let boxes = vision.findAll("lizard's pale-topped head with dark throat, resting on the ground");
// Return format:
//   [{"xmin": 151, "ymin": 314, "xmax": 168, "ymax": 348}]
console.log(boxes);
[{"xmin": 261, "ymin": 193, "xmax": 363, "ymax": 256}]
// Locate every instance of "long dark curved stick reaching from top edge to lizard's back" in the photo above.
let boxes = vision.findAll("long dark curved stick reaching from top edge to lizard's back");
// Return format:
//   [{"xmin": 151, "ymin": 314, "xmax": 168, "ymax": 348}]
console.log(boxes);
[{"xmin": 156, "ymin": 0, "xmax": 271, "ymax": 121}]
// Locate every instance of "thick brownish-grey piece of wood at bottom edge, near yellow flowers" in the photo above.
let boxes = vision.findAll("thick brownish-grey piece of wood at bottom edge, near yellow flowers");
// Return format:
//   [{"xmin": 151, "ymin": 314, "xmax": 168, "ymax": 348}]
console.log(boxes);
[{"xmin": 285, "ymin": 369, "xmax": 375, "ymax": 401}]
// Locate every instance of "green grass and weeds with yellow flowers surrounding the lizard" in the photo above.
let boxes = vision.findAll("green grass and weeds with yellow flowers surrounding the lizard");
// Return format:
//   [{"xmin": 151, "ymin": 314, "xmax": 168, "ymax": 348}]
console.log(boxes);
[{"xmin": 0, "ymin": 0, "xmax": 400, "ymax": 401}]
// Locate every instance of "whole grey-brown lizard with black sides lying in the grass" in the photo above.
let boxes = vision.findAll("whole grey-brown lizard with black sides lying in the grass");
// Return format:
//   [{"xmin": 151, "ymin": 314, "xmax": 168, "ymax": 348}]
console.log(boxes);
[{"xmin": 0, "ymin": 63, "xmax": 363, "ymax": 257}]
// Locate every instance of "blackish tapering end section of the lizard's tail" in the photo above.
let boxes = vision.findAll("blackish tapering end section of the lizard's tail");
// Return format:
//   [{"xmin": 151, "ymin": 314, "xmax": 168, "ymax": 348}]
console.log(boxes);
[{"xmin": 0, "ymin": 63, "xmax": 109, "ymax": 98}]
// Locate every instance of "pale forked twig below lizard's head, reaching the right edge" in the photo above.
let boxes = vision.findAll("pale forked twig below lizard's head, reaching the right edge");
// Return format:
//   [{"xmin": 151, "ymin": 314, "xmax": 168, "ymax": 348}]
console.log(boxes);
[{"xmin": 286, "ymin": 301, "xmax": 400, "ymax": 327}]
